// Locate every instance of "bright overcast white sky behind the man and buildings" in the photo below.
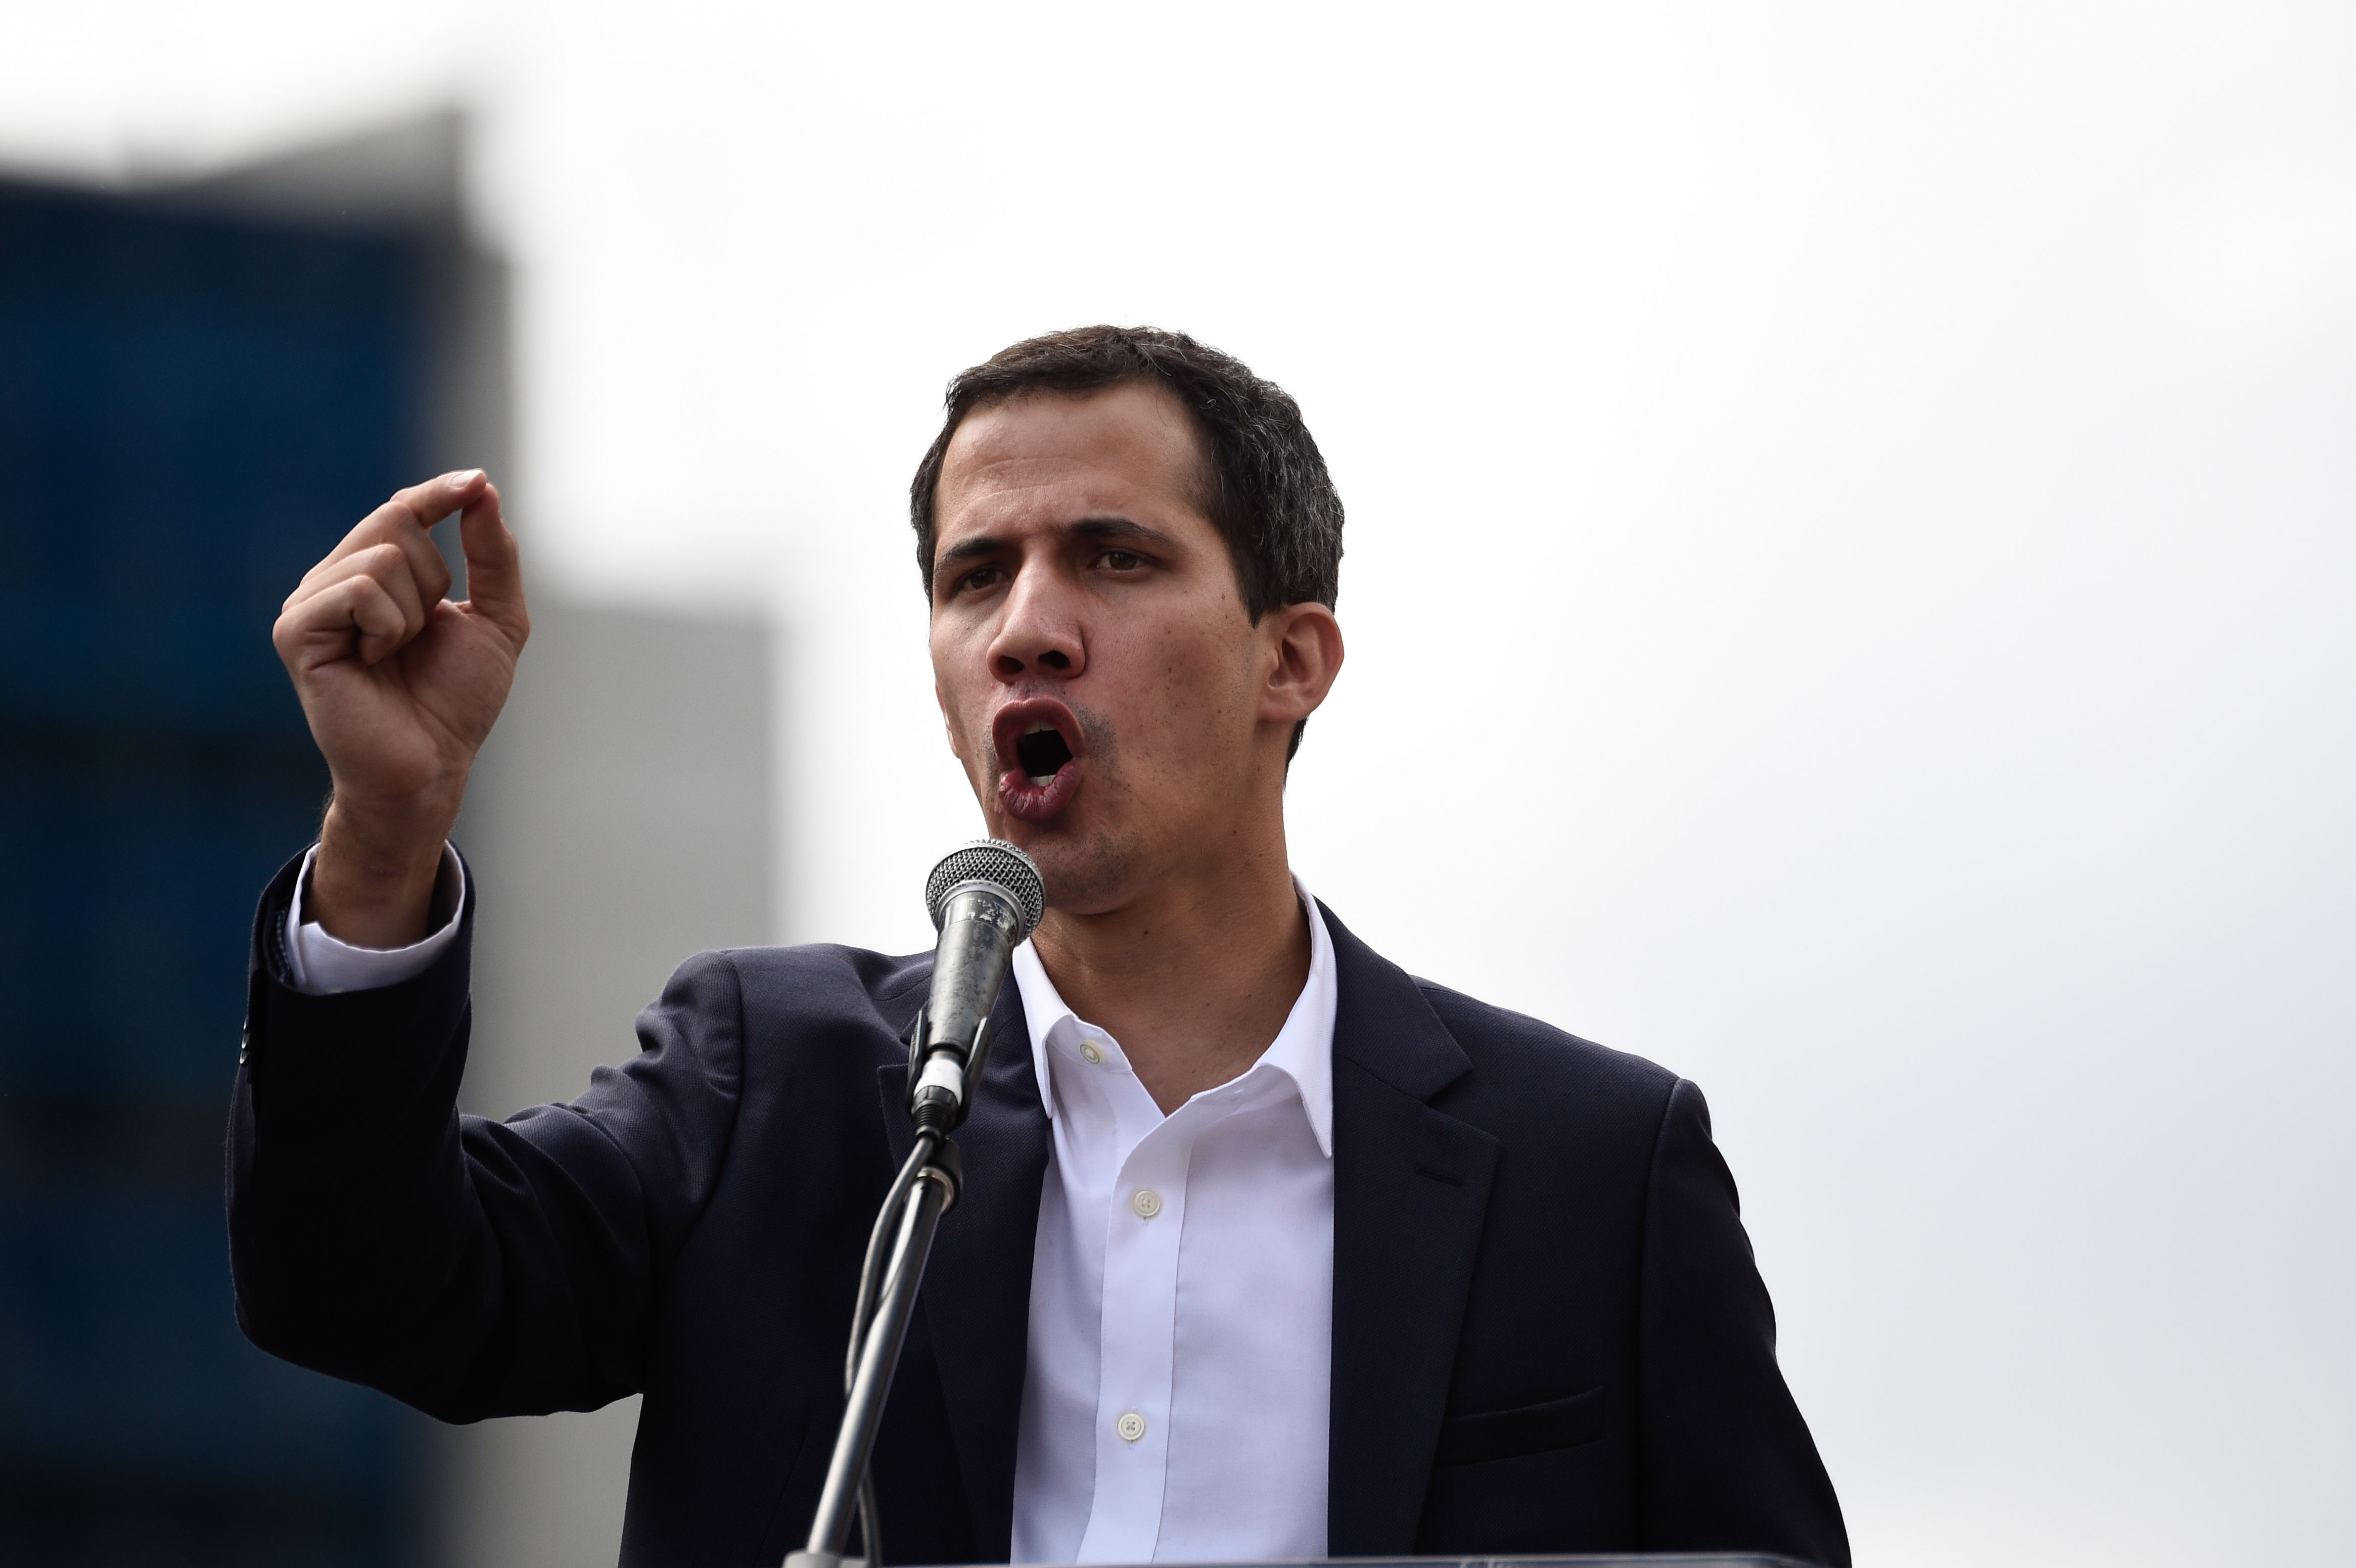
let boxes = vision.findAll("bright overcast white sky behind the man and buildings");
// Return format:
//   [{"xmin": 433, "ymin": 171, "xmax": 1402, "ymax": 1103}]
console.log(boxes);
[{"xmin": 0, "ymin": 0, "xmax": 2356, "ymax": 1568}]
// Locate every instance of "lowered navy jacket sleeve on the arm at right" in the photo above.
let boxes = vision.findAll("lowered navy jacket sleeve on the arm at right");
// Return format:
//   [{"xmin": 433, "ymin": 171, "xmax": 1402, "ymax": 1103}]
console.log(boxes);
[{"xmin": 1637, "ymin": 1081, "xmax": 1850, "ymax": 1568}]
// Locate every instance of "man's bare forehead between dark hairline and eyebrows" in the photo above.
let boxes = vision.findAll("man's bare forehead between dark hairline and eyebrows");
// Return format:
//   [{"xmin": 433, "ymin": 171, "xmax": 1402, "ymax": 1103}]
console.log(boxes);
[{"xmin": 933, "ymin": 384, "xmax": 1211, "ymax": 548}]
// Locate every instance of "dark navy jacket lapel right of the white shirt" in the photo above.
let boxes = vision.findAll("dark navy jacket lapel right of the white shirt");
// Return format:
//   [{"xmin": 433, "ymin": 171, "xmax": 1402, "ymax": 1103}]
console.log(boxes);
[{"xmin": 1319, "ymin": 904, "xmax": 1498, "ymax": 1556}]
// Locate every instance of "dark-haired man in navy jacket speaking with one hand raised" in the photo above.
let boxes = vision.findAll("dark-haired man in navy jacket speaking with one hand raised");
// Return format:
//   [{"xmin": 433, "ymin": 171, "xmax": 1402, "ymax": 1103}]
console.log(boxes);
[{"xmin": 228, "ymin": 327, "xmax": 1850, "ymax": 1568}]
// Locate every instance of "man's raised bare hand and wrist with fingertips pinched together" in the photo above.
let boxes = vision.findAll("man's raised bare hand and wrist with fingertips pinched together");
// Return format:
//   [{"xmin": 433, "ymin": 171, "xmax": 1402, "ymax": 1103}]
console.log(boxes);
[{"xmin": 271, "ymin": 469, "xmax": 532, "ymax": 946}]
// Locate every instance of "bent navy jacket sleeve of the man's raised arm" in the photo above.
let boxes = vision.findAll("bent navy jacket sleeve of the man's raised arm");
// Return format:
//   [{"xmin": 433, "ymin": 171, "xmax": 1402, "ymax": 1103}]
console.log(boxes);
[{"xmin": 228, "ymin": 862, "xmax": 745, "ymax": 1420}]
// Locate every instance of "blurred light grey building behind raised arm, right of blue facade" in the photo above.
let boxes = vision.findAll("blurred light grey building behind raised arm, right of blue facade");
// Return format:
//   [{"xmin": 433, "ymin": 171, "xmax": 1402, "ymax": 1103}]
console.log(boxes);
[{"xmin": 450, "ymin": 603, "xmax": 775, "ymax": 1568}]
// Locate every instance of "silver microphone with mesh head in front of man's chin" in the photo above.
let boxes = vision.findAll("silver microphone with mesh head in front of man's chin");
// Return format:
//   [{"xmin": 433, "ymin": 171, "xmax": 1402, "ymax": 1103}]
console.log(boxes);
[{"xmin": 907, "ymin": 838, "xmax": 1046, "ymax": 1132}]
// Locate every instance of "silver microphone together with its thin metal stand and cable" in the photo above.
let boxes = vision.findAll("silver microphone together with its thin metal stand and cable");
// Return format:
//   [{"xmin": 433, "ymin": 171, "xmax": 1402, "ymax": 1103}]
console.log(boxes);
[{"xmin": 784, "ymin": 838, "xmax": 1046, "ymax": 1568}]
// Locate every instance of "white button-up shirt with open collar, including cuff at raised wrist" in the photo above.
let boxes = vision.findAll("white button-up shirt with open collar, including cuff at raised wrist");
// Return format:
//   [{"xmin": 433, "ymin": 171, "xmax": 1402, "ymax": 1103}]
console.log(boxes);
[{"xmin": 285, "ymin": 848, "xmax": 1336, "ymax": 1563}]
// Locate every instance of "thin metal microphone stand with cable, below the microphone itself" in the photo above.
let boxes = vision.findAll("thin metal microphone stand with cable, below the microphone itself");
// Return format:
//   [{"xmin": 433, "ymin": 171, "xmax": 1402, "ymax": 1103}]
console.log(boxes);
[{"xmin": 784, "ymin": 1064, "xmax": 961, "ymax": 1568}]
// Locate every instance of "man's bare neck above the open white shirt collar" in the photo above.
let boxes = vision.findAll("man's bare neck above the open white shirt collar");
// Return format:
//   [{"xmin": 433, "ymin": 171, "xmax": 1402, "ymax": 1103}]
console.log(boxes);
[{"xmin": 1032, "ymin": 817, "xmax": 1310, "ymax": 1116}]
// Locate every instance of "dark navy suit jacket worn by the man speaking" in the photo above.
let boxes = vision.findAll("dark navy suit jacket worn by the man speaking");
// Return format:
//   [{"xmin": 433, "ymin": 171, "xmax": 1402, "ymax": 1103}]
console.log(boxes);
[{"xmin": 228, "ymin": 847, "xmax": 1850, "ymax": 1568}]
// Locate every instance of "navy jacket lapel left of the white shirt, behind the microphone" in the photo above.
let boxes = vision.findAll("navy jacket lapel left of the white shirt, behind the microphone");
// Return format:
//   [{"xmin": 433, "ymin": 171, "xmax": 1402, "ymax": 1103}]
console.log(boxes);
[{"xmin": 879, "ymin": 980, "xmax": 1048, "ymax": 1563}]
